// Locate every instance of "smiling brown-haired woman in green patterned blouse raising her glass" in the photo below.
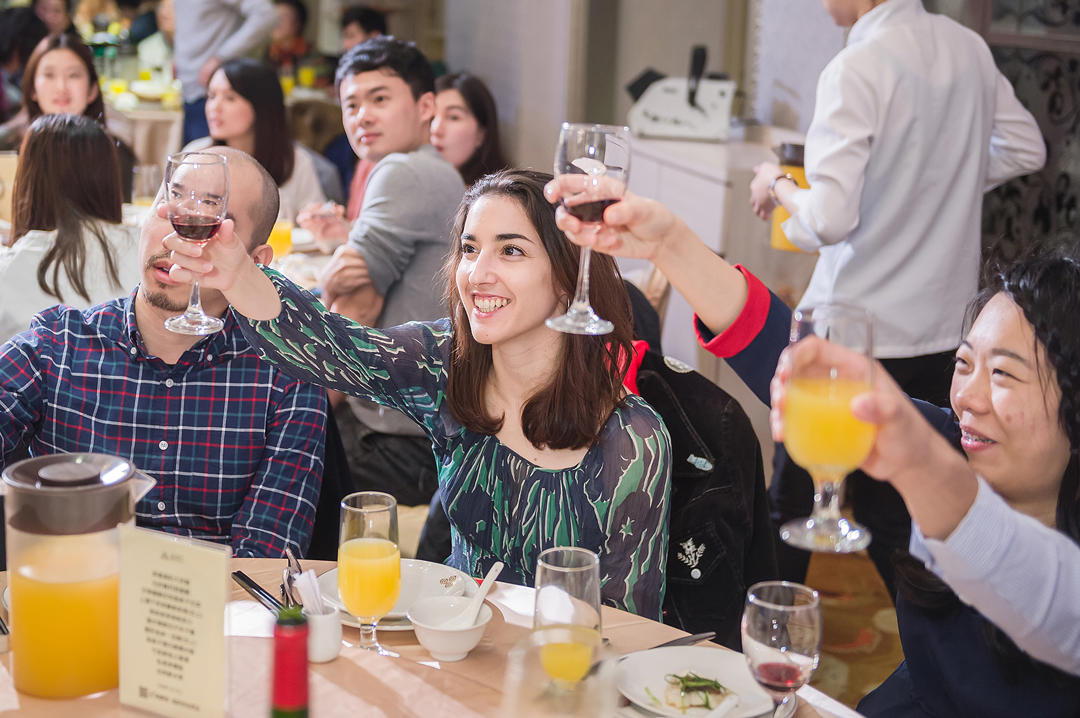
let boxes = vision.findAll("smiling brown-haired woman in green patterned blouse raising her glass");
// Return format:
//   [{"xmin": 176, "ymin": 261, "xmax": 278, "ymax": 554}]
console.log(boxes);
[{"xmin": 165, "ymin": 171, "xmax": 671, "ymax": 620}]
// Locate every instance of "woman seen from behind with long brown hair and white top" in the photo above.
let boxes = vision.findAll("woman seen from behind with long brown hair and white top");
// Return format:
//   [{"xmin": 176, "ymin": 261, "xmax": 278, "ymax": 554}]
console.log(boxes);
[{"xmin": 0, "ymin": 114, "xmax": 140, "ymax": 341}]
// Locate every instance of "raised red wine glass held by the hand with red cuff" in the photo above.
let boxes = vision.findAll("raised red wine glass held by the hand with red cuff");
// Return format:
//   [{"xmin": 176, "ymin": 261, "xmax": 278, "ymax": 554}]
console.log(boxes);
[{"xmin": 546, "ymin": 122, "xmax": 630, "ymax": 334}]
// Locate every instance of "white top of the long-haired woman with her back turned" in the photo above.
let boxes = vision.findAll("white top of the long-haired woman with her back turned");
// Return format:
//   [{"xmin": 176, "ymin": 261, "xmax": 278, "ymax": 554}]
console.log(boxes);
[{"xmin": 0, "ymin": 222, "xmax": 141, "ymax": 342}]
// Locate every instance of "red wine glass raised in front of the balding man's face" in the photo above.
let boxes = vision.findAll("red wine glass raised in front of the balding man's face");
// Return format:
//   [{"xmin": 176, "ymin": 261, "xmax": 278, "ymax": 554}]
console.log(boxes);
[{"xmin": 165, "ymin": 152, "xmax": 229, "ymax": 335}]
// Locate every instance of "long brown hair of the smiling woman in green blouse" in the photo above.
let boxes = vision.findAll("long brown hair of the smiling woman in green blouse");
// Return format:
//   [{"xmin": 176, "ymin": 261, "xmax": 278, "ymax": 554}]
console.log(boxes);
[{"xmin": 444, "ymin": 170, "xmax": 633, "ymax": 449}]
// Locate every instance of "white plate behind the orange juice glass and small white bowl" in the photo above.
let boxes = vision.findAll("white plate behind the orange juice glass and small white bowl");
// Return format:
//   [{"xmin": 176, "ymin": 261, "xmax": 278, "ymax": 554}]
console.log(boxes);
[{"xmin": 319, "ymin": 558, "xmax": 477, "ymax": 631}]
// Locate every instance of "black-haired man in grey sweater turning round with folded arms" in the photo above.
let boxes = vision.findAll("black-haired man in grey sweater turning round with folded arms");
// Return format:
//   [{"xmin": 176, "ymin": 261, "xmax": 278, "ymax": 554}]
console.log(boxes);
[{"xmin": 301, "ymin": 37, "xmax": 464, "ymax": 505}]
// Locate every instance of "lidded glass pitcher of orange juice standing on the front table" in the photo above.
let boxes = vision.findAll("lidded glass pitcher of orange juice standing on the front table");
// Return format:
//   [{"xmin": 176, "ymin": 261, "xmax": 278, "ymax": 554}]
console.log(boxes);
[{"xmin": 2, "ymin": 453, "xmax": 154, "ymax": 699}]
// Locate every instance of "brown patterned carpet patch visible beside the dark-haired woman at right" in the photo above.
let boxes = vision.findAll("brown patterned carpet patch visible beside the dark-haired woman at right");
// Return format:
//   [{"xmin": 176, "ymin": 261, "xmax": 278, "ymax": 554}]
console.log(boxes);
[{"xmin": 807, "ymin": 552, "xmax": 904, "ymax": 708}]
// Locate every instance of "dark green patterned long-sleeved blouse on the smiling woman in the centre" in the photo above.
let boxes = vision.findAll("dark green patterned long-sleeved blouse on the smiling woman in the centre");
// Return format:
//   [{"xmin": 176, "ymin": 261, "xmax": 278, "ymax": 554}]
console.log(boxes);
[{"xmin": 241, "ymin": 270, "xmax": 671, "ymax": 620}]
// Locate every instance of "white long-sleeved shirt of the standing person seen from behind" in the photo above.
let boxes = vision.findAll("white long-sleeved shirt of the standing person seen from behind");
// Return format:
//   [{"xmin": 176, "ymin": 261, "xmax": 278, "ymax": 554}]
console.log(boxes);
[{"xmin": 783, "ymin": 0, "xmax": 1045, "ymax": 357}]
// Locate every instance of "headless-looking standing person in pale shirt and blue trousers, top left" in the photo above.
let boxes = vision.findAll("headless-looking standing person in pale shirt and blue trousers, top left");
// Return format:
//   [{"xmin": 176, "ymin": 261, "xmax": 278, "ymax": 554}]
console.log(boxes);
[{"xmin": 173, "ymin": 0, "xmax": 278, "ymax": 145}]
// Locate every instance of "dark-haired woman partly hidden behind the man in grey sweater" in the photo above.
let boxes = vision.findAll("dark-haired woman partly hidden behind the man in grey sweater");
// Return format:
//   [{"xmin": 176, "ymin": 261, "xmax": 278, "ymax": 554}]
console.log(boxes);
[{"xmin": 431, "ymin": 72, "xmax": 508, "ymax": 185}]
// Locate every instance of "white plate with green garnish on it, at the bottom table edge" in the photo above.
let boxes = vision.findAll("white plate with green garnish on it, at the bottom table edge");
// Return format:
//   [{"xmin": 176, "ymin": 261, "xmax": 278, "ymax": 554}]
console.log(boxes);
[{"xmin": 619, "ymin": 646, "xmax": 772, "ymax": 718}]
